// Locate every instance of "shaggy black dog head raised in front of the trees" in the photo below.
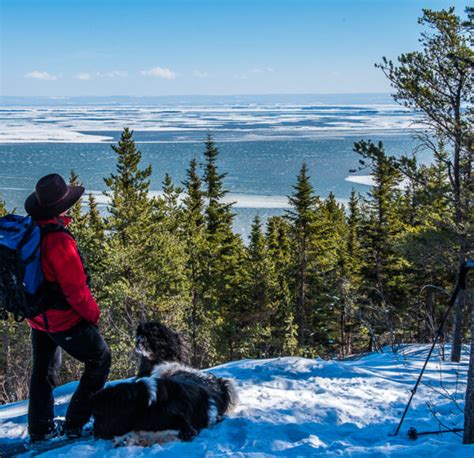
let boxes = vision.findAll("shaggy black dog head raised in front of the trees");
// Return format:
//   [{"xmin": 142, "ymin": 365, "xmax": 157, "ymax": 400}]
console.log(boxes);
[{"xmin": 135, "ymin": 321, "xmax": 189, "ymax": 364}]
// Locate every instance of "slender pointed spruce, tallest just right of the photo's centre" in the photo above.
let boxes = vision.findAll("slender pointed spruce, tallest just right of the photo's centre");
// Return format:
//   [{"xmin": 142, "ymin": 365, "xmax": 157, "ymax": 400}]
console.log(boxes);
[{"xmin": 287, "ymin": 163, "xmax": 319, "ymax": 347}]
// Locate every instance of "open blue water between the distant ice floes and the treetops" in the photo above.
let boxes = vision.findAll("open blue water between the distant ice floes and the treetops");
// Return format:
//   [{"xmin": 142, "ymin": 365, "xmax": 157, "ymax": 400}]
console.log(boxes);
[{"xmin": 0, "ymin": 135, "xmax": 422, "ymax": 240}]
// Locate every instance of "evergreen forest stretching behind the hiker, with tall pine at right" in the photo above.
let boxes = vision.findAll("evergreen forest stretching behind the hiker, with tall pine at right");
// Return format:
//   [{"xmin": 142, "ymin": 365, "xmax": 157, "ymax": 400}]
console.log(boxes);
[{"xmin": 0, "ymin": 9, "xmax": 474, "ymax": 434}]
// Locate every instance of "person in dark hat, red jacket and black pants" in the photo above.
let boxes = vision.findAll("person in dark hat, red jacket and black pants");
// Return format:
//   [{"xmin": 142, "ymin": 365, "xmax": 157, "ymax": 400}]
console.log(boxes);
[{"xmin": 25, "ymin": 174, "xmax": 111, "ymax": 442}]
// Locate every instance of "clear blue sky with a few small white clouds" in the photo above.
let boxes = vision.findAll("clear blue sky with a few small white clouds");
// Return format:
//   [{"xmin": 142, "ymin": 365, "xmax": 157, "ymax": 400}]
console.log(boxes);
[{"xmin": 0, "ymin": 0, "xmax": 469, "ymax": 96}]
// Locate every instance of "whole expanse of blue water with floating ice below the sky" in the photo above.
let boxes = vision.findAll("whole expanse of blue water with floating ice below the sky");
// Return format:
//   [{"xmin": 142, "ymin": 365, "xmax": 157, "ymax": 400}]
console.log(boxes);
[{"xmin": 0, "ymin": 94, "xmax": 429, "ymax": 237}]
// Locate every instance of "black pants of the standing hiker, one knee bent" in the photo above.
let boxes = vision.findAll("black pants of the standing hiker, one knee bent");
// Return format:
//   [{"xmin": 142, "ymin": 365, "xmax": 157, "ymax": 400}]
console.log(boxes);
[{"xmin": 28, "ymin": 321, "xmax": 111, "ymax": 434}]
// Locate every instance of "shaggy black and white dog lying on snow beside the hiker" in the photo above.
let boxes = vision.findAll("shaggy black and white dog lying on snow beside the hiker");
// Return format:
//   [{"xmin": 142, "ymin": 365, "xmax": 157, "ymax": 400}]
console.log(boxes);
[{"xmin": 92, "ymin": 323, "xmax": 237, "ymax": 445}]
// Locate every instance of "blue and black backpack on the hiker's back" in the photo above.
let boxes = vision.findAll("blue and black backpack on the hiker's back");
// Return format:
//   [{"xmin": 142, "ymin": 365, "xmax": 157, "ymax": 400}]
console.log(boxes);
[{"xmin": 0, "ymin": 215, "xmax": 44, "ymax": 321}]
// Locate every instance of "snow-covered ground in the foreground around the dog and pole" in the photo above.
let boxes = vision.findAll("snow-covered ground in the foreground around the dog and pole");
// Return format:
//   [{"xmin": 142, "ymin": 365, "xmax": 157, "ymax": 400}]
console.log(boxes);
[{"xmin": 0, "ymin": 345, "xmax": 474, "ymax": 458}]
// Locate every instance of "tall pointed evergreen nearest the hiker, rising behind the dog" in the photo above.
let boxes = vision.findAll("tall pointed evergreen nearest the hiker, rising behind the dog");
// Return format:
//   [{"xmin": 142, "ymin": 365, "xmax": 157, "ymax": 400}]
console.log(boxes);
[{"xmin": 102, "ymin": 128, "xmax": 162, "ymax": 375}]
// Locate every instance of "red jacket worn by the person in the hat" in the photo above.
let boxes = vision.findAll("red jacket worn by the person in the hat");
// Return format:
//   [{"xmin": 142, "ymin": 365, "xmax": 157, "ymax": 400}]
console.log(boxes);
[{"xmin": 27, "ymin": 217, "xmax": 100, "ymax": 332}]
